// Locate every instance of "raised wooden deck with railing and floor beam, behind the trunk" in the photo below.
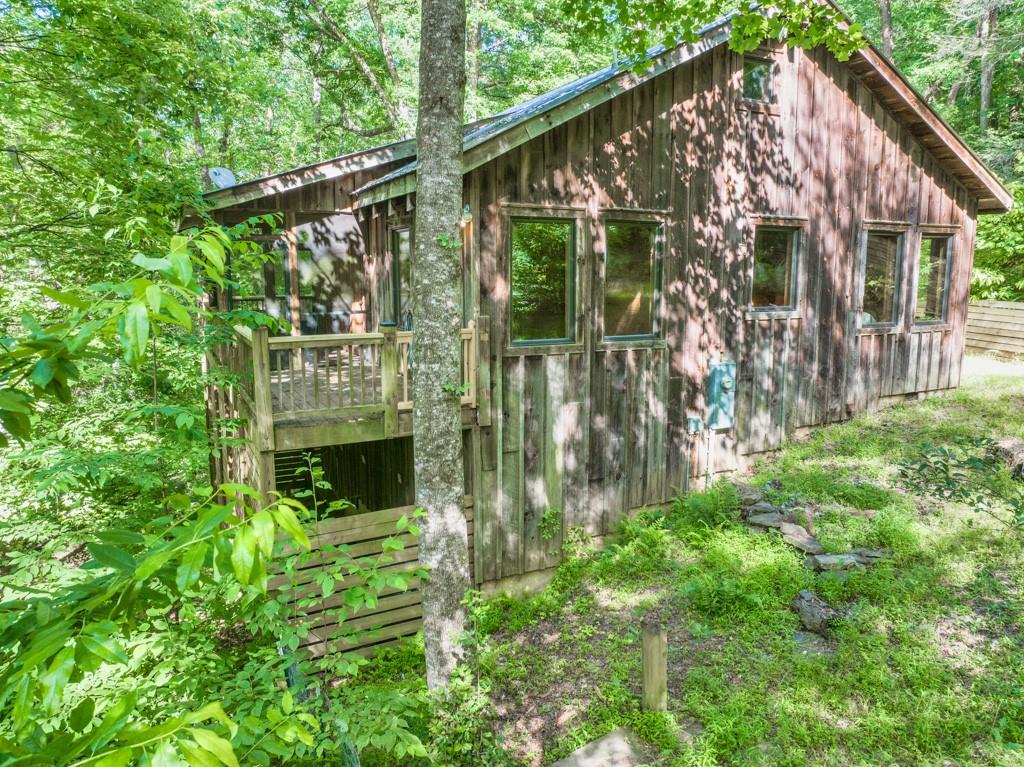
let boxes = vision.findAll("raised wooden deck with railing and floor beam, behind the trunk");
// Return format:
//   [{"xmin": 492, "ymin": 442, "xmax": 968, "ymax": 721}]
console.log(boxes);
[{"xmin": 214, "ymin": 317, "xmax": 486, "ymax": 451}]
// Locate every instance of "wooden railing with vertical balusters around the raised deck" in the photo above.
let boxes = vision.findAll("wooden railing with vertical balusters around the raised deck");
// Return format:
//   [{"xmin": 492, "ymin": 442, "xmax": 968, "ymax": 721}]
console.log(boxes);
[{"xmin": 216, "ymin": 322, "xmax": 480, "ymax": 434}]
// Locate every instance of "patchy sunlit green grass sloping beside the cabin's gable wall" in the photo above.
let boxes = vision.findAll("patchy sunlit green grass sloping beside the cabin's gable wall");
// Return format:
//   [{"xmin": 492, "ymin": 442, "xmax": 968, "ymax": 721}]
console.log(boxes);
[{"xmin": 358, "ymin": 358, "xmax": 1024, "ymax": 767}]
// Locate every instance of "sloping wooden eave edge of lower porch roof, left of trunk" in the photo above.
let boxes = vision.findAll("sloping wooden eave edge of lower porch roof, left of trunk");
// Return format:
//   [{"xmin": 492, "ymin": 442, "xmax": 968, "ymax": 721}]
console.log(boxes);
[{"xmin": 203, "ymin": 138, "xmax": 416, "ymax": 210}]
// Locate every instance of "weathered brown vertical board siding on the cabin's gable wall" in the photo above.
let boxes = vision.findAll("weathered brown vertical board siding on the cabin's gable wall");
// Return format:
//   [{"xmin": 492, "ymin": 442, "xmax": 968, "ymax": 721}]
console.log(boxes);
[{"xmin": 370, "ymin": 41, "xmax": 976, "ymax": 582}]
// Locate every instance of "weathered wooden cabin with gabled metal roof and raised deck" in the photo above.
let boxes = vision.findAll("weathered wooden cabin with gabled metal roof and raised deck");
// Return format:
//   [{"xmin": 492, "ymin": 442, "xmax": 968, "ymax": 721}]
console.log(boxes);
[{"xmin": 199, "ymin": 20, "xmax": 1011, "ymax": 651}]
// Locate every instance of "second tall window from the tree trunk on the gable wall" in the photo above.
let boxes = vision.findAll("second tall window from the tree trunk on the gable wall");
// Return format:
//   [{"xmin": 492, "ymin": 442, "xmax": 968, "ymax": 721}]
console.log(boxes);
[{"xmin": 604, "ymin": 221, "xmax": 660, "ymax": 338}]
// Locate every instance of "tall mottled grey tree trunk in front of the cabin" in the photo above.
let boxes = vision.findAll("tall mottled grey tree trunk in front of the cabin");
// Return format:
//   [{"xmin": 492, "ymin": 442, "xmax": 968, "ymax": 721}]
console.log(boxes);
[{"xmin": 413, "ymin": 0, "xmax": 470, "ymax": 688}]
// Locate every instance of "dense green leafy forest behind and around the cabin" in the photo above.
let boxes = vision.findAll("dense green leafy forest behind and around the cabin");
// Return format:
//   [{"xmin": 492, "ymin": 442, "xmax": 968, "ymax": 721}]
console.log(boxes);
[{"xmin": 0, "ymin": 0, "xmax": 1024, "ymax": 764}]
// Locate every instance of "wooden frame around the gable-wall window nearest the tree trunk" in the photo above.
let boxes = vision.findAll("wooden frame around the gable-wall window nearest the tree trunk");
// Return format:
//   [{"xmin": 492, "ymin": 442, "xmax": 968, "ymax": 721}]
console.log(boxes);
[{"xmin": 501, "ymin": 209, "xmax": 588, "ymax": 354}]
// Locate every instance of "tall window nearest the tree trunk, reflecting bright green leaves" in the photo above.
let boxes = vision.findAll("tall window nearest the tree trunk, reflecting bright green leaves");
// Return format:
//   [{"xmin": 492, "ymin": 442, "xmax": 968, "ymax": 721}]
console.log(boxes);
[{"xmin": 510, "ymin": 219, "xmax": 575, "ymax": 343}]
